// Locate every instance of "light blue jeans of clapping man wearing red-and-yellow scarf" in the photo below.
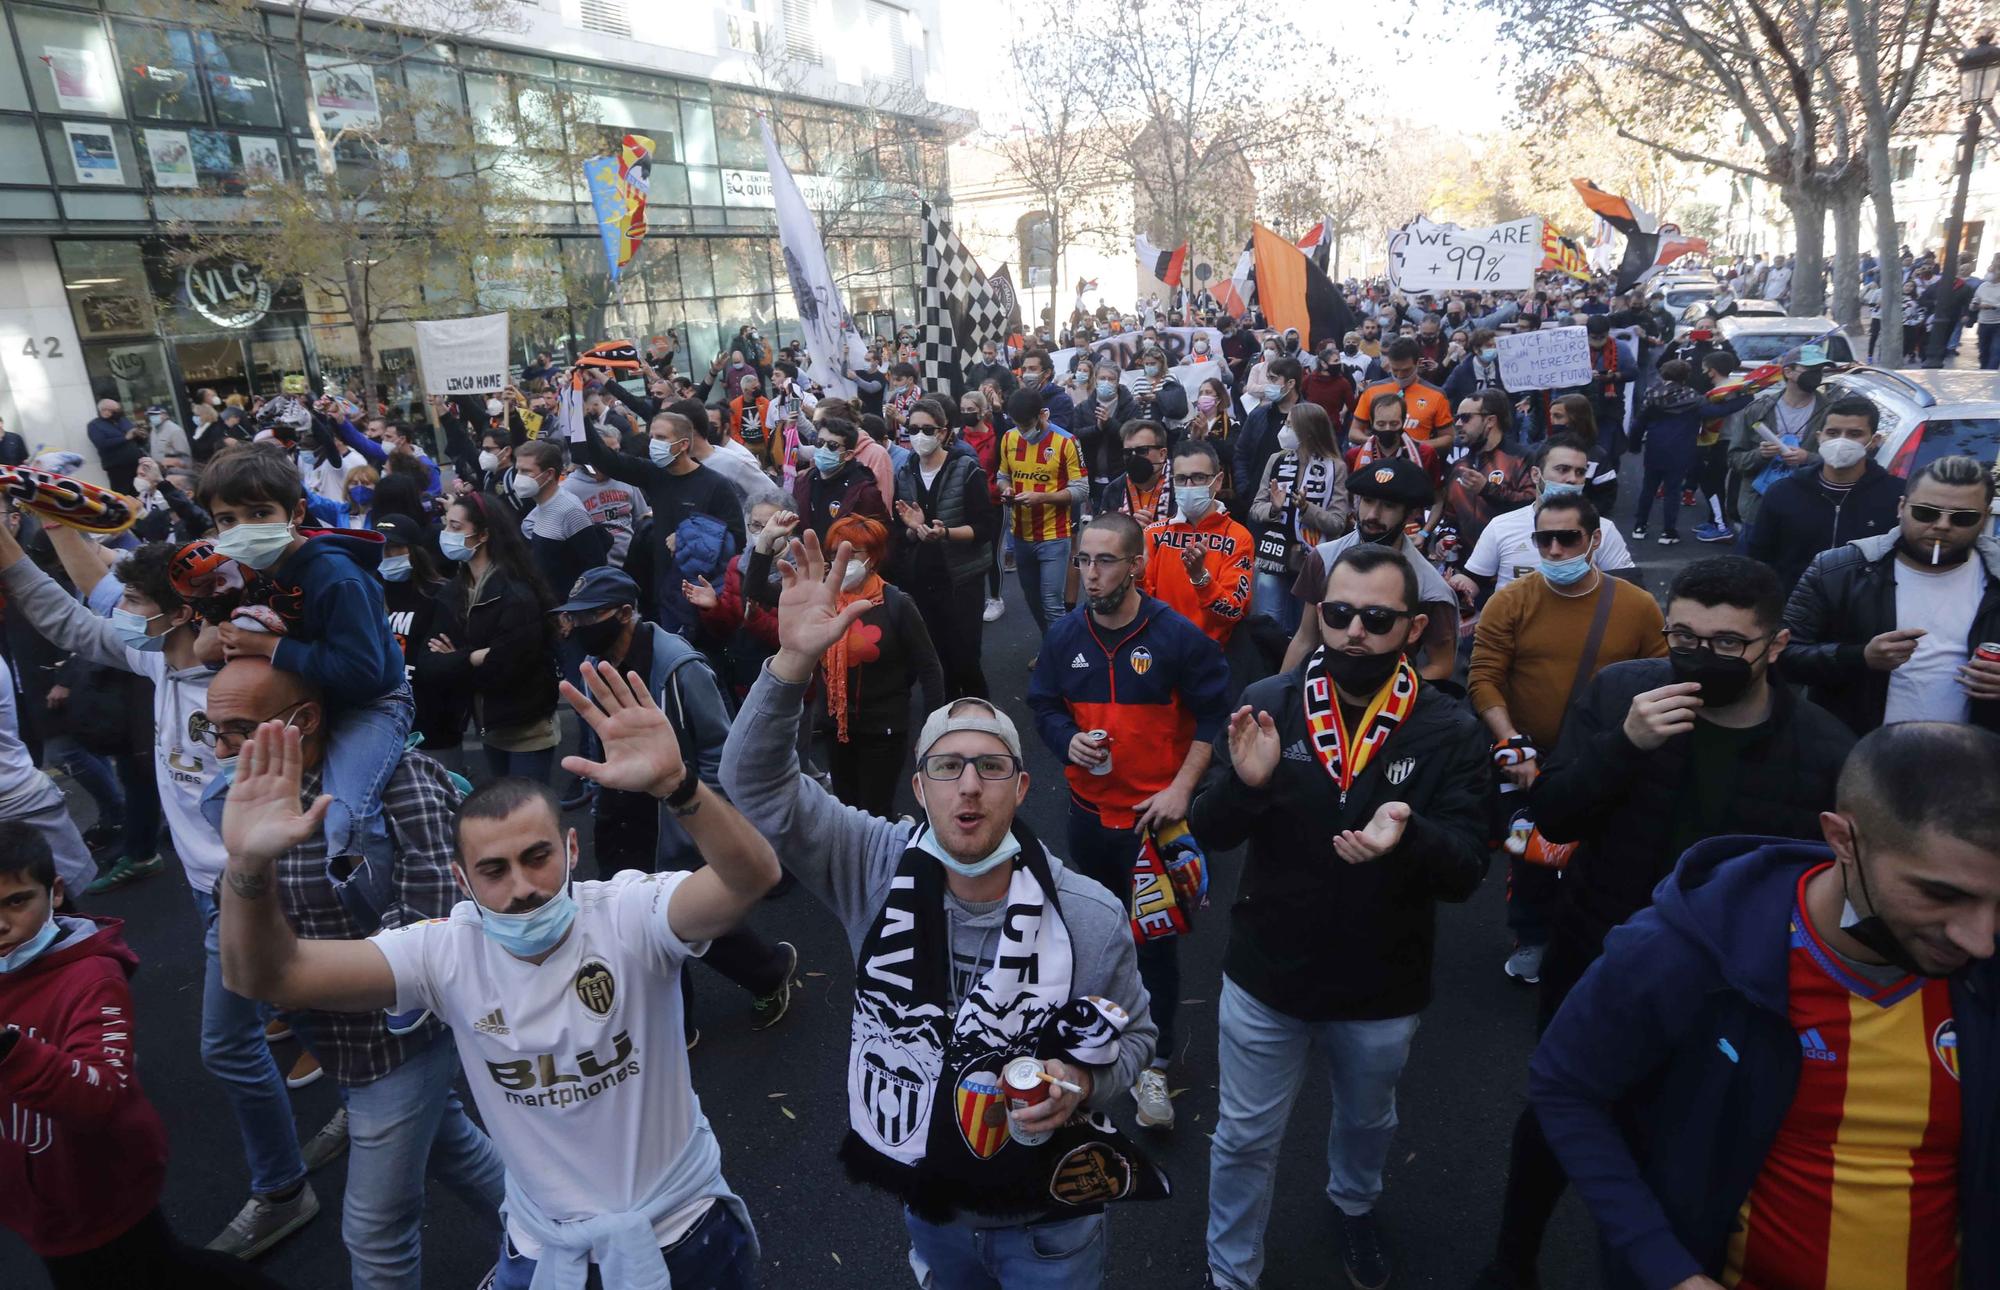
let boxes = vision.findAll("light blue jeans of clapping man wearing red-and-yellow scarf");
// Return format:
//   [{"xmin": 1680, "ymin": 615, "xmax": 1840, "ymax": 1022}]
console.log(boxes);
[{"xmin": 1208, "ymin": 976, "xmax": 1416, "ymax": 1290}]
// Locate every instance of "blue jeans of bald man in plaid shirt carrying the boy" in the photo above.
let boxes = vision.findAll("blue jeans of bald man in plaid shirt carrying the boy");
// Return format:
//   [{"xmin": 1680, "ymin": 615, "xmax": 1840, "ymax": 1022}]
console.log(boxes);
[{"xmin": 340, "ymin": 1036, "xmax": 506, "ymax": 1290}]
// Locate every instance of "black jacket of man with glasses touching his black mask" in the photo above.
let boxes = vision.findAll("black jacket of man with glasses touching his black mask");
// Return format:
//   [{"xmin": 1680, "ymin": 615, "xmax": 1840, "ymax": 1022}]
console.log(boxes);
[{"xmin": 1530, "ymin": 658, "xmax": 1854, "ymax": 938}]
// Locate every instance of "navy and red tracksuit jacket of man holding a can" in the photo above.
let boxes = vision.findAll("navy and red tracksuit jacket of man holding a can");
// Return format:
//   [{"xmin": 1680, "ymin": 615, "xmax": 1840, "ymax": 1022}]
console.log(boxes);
[{"xmin": 1028, "ymin": 596, "xmax": 1230, "ymax": 828}]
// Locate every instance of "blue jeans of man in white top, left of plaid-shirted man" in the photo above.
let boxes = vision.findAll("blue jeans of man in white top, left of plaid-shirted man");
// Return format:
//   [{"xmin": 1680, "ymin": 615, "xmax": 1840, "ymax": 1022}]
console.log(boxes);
[{"xmin": 194, "ymin": 892, "xmax": 306, "ymax": 1196}]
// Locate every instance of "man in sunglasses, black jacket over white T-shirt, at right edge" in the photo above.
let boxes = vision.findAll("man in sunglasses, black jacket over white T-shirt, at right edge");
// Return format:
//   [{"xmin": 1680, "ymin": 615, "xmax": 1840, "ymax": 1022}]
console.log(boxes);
[{"xmin": 1784, "ymin": 456, "xmax": 2000, "ymax": 734}]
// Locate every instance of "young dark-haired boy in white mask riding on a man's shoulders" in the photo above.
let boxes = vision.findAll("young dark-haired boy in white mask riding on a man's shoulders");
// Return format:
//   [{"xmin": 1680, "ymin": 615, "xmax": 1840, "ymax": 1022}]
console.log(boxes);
[{"xmin": 200, "ymin": 446, "xmax": 414, "ymax": 926}]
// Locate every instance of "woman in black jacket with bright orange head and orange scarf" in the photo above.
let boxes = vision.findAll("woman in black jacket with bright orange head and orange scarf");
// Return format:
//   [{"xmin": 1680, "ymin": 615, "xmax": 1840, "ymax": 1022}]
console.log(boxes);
[{"xmin": 820, "ymin": 516, "xmax": 944, "ymax": 818}]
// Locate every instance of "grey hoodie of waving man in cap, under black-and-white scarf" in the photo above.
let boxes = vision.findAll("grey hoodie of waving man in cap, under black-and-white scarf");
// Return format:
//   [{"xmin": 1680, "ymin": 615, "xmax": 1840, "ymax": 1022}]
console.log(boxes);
[{"xmin": 722, "ymin": 664, "xmax": 1158, "ymax": 1108}]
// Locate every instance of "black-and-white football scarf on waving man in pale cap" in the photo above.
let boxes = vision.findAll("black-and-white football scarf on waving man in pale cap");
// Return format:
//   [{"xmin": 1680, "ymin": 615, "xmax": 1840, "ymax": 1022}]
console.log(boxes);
[{"xmin": 840, "ymin": 820, "xmax": 1168, "ymax": 1222}]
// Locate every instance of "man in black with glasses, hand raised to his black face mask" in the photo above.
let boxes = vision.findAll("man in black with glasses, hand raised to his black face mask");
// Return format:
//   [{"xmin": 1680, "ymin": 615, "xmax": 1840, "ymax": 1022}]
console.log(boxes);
[{"xmin": 1480, "ymin": 556, "xmax": 1854, "ymax": 1290}]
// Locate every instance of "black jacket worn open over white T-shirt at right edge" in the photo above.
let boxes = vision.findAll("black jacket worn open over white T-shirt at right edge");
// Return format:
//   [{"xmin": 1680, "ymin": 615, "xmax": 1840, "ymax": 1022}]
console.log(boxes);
[{"xmin": 1778, "ymin": 530, "xmax": 2000, "ymax": 734}]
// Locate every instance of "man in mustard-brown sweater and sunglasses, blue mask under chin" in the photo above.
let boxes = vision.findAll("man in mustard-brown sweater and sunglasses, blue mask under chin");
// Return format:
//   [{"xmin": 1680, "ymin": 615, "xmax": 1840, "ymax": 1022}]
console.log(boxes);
[{"xmin": 1466, "ymin": 492, "xmax": 1666, "ymax": 986}]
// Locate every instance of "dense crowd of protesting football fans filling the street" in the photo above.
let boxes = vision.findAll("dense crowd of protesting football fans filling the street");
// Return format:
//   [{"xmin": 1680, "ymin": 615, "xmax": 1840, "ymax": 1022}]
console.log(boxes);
[{"xmin": 0, "ymin": 252, "xmax": 2000, "ymax": 1290}]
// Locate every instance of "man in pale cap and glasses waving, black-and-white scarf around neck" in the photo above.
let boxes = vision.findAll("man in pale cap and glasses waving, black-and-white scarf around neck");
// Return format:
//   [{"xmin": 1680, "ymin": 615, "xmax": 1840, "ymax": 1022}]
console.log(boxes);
[{"xmin": 722, "ymin": 520, "xmax": 1160, "ymax": 1290}]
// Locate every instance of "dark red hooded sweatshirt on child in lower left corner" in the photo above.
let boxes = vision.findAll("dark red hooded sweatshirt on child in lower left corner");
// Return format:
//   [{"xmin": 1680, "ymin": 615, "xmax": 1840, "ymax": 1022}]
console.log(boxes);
[{"xmin": 0, "ymin": 916, "xmax": 166, "ymax": 1258}]
